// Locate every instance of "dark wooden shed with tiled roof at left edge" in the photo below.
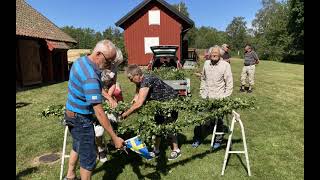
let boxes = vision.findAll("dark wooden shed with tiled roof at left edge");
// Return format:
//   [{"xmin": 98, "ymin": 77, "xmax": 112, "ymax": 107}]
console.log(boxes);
[{"xmin": 16, "ymin": 0, "xmax": 76, "ymax": 87}]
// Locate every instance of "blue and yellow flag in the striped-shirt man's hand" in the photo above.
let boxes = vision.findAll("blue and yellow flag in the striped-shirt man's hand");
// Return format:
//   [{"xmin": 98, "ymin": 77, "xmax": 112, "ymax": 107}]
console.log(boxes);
[{"xmin": 125, "ymin": 136, "xmax": 153, "ymax": 159}]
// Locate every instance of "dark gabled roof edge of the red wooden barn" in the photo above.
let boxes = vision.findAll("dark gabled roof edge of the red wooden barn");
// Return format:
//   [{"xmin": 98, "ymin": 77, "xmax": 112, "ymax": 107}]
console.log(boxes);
[{"xmin": 115, "ymin": 0, "xmax": 194, "ymax": 28}]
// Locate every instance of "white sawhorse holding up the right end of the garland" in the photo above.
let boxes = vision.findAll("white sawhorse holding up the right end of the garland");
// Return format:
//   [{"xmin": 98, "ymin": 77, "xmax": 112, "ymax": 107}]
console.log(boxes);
[{"xmin": 211, "ymin": 111, "xmax": 251, "ymax": 176}]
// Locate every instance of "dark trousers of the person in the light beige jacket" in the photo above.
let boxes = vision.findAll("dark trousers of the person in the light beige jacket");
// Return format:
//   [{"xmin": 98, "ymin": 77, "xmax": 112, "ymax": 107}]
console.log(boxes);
[{"xmin": 193, "ymin": 118, "xmax": 224, "ymax": 143}]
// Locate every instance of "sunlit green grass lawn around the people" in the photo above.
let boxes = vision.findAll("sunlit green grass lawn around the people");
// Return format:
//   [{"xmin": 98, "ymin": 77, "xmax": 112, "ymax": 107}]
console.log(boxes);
[{"xmin": 16, "ymin": 59, "xmax": 304, "ymax": 180}]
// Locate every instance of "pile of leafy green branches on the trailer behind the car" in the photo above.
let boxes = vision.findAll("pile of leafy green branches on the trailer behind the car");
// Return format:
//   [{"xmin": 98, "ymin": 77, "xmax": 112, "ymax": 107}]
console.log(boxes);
[{"xmin": 144, "ymin": 67, "xmax": 185, "ymax": 80}]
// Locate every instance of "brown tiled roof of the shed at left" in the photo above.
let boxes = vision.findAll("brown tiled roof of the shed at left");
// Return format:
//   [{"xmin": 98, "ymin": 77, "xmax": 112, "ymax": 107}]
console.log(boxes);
[{"xmin": 16, "ymin": 0, "xmax": 77, "ymax": 43}]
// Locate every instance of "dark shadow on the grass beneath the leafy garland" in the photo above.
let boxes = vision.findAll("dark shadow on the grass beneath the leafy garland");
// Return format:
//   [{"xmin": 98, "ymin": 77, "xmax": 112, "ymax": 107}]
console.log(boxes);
[{"xmin": 92, "ymin": 134, "xmax": 242, "ymax": 180}]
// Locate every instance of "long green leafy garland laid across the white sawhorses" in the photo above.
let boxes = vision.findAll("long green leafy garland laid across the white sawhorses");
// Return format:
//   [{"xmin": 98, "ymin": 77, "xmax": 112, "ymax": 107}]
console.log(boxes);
[{"xmin": 41, "ymin": 97, "xmax": 254, "ymax": 145}]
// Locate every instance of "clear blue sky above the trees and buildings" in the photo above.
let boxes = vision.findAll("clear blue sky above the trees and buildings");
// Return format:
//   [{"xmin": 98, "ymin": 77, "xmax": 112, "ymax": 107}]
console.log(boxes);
[{"xmin": 25, "ymin": 0, "xmax": 262, "ymax": 32}]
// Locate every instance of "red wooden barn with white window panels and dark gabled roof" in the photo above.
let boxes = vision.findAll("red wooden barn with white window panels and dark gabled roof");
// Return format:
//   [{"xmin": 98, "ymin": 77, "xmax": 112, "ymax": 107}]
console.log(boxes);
[{"xmin": 116, "ymin": 0, "xmax": 194, "ymax": 65}]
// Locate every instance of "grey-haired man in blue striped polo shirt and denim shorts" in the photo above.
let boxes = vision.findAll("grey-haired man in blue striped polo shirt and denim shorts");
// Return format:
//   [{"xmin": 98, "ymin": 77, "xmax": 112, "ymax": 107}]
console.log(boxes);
[{"xmin": 65, "ymin": 40, "xmax": 124, "ymax": 180}]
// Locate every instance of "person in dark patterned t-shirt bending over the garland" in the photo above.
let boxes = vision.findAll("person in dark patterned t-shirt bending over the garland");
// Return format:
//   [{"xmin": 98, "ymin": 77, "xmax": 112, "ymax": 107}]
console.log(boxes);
[{"xmin": 122, "ymin": 64, "xmax": 181, "ymax": 160}]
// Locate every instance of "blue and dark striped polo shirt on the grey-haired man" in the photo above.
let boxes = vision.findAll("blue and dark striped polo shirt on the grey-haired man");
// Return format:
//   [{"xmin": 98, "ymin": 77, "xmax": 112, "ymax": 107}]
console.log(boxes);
[{"xmin": 66, "ymin": 56, "xmax": 102, "ymax": 114}]
